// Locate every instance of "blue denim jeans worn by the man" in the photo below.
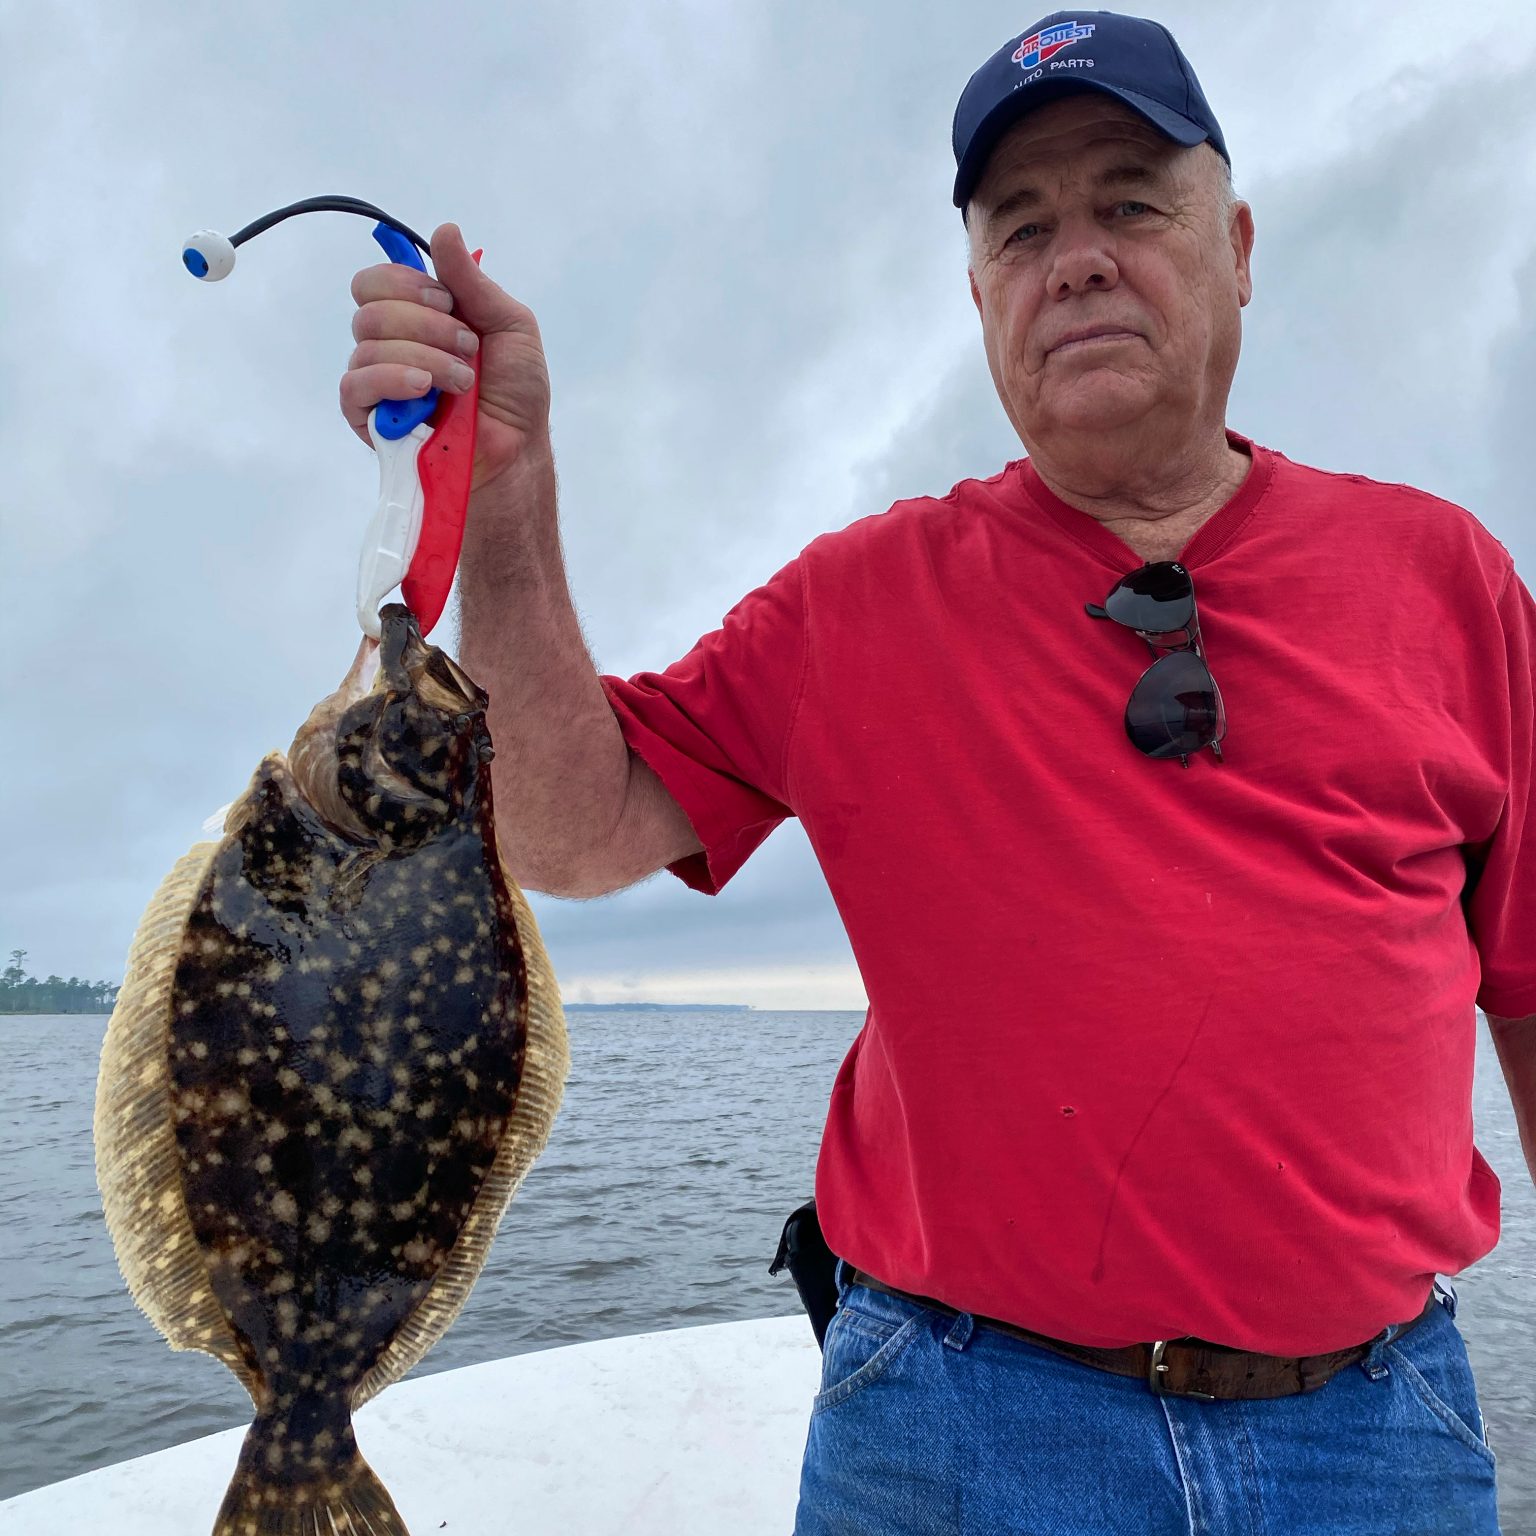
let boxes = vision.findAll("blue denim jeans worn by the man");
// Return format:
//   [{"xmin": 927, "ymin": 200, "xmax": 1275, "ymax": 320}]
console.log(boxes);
[{"xmin": 794, "ymin": 1264, "xmax": 1499, "ymax": 1536}]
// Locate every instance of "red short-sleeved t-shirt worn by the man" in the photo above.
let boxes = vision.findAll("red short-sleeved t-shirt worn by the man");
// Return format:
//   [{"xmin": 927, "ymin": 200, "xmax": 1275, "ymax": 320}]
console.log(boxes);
[{"xmin": 604, "ymin": 435, "xmax": 1536, "ymax": 1355}]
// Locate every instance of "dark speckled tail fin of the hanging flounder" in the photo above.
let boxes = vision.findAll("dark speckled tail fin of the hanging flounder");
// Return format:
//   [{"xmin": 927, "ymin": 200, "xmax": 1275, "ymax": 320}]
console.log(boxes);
[{"xmin": 212, "ymin": 1415, "xmax": 410, "ymax": 1536}]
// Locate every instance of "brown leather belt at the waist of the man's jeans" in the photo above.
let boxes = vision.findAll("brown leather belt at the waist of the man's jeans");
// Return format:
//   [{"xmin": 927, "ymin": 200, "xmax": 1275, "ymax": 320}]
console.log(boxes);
[{"xmin": 848, "ymin": 1264, "xmax": 1436, "ymax": 1402}]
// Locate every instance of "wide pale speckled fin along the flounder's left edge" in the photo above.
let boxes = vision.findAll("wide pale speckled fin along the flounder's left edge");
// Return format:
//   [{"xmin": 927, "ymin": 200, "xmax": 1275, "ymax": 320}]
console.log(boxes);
[{"xmin": 92, "ymin": 842, "xmax": 260, "ymax": 1399}]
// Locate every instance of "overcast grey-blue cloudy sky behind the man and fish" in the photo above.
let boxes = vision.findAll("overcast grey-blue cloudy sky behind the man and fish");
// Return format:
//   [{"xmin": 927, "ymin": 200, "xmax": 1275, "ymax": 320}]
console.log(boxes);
[{"xmin": 0, "ymin": 0, "xmax": 1536, "ymax": 1008}]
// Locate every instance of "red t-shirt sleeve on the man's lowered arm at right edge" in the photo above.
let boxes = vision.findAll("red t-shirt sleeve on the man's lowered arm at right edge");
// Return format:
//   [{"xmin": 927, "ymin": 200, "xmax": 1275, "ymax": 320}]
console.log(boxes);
[{"xmin": 1465, "ymin": 570, "xmax": 1536, "ymax": 1018}]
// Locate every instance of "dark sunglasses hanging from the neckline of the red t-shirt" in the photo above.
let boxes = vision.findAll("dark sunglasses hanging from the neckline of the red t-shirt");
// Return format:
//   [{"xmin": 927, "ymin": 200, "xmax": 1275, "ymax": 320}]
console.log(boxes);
[{"xmin": 1084, "ymin": 561, "xmax": 1227, "ymax": 768}]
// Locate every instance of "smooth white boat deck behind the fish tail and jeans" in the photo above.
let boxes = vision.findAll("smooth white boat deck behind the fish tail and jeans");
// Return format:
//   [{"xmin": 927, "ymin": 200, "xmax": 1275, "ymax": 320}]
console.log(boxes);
[{"xmin": 0, "ymin": 1316, "xmax": 820, "ymax": 1536}]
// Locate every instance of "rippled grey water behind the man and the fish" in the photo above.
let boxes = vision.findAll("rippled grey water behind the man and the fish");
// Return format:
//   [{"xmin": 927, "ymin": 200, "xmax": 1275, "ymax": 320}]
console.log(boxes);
[{"xmin": 0, "ymin": 1009, "xmax": 1536, "ymax": 1533}]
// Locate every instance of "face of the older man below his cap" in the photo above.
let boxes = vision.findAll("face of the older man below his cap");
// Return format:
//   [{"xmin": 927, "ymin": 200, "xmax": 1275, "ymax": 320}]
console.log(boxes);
[{"xmin": 966, "ymin": 92, "xmax": 1253, "ymax": 452}]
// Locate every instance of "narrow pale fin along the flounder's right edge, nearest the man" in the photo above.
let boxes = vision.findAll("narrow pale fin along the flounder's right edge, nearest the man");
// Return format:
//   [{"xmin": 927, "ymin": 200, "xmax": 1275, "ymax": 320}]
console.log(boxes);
[{"xmin": 352, "ymin": 863, "xmax": 570, "ymax": 1410}]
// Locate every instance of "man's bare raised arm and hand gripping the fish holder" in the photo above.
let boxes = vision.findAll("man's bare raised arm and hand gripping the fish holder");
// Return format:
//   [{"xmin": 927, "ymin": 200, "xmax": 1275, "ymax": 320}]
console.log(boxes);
[{"xmin": 341, "ymin": 224, "xmax": 700, "ymax": 895}]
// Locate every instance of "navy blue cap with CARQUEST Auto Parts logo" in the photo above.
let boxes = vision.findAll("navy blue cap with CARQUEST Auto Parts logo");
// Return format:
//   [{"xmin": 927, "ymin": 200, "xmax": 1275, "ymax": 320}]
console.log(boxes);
[{"xmin": 954, "ymin": 11, "xmax": 1232, "ymax": 207}]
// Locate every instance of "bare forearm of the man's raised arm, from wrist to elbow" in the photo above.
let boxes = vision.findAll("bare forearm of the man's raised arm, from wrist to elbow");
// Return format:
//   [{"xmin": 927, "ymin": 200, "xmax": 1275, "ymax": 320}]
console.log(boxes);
[{"xmin": 459, "ymin": 444, "xmax": 630, "ymax": 895}]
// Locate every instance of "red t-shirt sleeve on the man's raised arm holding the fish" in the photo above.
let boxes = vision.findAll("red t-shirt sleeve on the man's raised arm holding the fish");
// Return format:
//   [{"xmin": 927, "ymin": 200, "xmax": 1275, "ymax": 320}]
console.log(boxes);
[{"xmin": 602, "ymin": 561, "xmax": 806, "ymax": 895}]
